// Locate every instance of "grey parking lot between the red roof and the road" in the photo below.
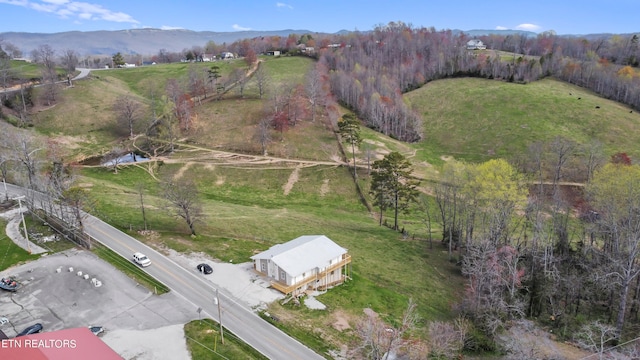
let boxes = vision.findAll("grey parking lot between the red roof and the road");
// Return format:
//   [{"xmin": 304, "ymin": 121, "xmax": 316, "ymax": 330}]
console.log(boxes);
[{"xmin": 0, "ymin": 249, "xmax": 198, "ymax": 359}]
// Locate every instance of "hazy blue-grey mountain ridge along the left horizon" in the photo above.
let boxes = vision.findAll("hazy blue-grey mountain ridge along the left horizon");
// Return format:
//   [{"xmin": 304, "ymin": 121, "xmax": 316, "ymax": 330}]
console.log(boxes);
[{"xmin": 0, "ymin": 29, "xmax": 315, "ymax": 57}]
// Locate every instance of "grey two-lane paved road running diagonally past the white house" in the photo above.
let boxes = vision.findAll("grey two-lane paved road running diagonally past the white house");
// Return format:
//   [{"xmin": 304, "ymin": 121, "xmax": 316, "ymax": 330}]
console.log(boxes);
[{"xmin": 7, "ymin": 184, "xmax": 323, "ymax": 360}]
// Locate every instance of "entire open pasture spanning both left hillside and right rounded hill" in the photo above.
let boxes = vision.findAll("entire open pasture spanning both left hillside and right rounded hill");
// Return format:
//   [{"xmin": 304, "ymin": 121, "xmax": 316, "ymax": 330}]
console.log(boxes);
[{"xmin": 5, "ymin": 47, "xmax": 640, "ymax": 358}]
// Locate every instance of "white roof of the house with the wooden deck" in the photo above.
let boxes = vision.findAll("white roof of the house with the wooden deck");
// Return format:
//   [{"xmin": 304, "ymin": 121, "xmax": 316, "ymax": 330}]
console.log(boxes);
[{"xmin": 251, "ymin": 235, "xmax": 347, "ymax": 276}]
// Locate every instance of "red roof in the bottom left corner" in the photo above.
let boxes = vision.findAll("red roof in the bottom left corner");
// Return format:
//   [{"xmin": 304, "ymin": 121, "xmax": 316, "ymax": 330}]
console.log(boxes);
[{"xmin": 0, "ymin": 328, "xmax": 122, "ymax": 360}]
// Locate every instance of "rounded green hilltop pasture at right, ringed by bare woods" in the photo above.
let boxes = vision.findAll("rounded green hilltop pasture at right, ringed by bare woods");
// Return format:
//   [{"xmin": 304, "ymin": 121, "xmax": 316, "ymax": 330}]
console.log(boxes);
[{"xmin": 405, "ymin": 78, "xmax": 640, "ymax": 161}]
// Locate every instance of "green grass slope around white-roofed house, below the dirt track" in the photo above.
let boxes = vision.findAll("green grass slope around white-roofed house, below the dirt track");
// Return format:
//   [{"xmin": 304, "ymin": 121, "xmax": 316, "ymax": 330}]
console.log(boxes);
[{"xmin": 81, "ymin": 156, "xmax": 462, "ymax": 352}]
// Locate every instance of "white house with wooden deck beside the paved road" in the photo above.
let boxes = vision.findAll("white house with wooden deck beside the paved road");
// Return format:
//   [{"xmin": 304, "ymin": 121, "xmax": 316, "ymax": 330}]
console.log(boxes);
[{"xmin": 251, "ymin": 235, "xmax": 351, "ymax": 295}]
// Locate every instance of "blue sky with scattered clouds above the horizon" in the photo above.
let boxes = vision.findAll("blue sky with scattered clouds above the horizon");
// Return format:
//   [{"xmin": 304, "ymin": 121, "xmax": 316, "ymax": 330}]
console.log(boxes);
[{"xmin": 0, "ymin": 0, "xmax": 640, "ymax": 34}]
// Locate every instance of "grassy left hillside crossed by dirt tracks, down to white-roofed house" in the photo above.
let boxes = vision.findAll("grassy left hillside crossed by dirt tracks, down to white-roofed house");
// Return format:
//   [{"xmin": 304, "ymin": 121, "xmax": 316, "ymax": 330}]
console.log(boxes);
[{"xmin": 17, "ymin": 57, "xmax": 462, "ymax": 349}]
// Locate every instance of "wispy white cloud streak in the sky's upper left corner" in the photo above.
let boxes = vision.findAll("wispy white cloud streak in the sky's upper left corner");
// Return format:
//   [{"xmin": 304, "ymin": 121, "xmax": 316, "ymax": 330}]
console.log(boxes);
[{"xmin": 0, "ymin": 0, "xmax": 139, "ymax": 24}]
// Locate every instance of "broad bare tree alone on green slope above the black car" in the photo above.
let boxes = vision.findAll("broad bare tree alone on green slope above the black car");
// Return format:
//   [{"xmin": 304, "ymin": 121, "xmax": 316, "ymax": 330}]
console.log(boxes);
[{"xmin": 162, "ymin": 177, "xmax": 203, "ymax": 236}]
